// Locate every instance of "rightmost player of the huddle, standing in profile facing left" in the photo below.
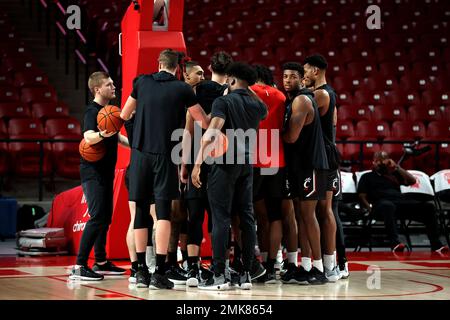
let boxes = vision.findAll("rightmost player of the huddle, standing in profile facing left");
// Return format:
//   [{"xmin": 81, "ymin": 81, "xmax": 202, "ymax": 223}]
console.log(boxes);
[{"xmin": 304, "ymin": 54, "xmax": 345, "ymax": 282}]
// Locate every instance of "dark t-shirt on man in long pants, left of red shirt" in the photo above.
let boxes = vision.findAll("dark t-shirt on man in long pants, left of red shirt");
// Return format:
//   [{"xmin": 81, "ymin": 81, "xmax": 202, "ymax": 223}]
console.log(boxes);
[{"xmin": 211, "ymin": 89, "xmax": 267, "ymax": 164}]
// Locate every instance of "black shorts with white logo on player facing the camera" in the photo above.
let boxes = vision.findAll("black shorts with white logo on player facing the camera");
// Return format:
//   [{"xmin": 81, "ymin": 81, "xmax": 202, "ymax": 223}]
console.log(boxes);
[{"xmin": 289, "ymin": 169, "xmax": 328, "ymax": 201}]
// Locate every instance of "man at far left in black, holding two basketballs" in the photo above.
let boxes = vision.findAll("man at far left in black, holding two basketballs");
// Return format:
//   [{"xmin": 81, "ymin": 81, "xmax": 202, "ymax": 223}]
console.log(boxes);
[{"xmin": 69, "ymin": 72, "xmax": 129, "ymax": 280}]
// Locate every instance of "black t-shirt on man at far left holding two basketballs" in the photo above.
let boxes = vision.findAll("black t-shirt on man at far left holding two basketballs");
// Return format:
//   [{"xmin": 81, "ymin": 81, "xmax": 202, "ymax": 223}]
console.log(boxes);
[{"xmin": 80, "ymin": 101, "xmax": 118, "ymax": 182}]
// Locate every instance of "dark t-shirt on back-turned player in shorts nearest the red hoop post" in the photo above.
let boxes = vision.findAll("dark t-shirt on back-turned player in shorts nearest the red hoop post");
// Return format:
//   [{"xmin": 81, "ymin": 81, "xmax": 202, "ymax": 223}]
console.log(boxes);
[{"xmin": 131, "ymin": 71, "xmax": 197, "ymax": 154}]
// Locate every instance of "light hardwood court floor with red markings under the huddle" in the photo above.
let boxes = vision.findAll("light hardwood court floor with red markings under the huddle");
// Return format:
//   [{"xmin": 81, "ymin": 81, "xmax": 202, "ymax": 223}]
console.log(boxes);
[{"xmin": 0, "ymin": 251, "xmax": 450, "ymax": 300}]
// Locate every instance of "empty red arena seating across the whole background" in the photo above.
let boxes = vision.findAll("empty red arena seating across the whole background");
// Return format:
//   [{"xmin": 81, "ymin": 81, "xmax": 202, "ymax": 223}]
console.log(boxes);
[{"xmin": 0, "ymin": 0, "xmax": 450, "ymax": 178}]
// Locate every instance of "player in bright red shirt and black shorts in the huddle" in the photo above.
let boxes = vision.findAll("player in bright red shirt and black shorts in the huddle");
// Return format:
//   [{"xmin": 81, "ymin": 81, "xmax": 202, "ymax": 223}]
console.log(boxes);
[{"xmin": 251, "ymin": 65, "xmax": 297, "ymax": 283}]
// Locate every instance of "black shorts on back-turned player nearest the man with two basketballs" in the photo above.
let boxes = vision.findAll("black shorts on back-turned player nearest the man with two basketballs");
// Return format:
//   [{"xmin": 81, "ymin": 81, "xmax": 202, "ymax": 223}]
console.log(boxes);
[{"xmin": 128, "ymin": 149, "xmax": 179, "ymax": 201}]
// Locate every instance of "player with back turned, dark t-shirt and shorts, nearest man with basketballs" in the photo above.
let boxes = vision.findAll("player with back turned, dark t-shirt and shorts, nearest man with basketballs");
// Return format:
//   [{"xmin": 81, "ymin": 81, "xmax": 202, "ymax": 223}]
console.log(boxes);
[{"xmin": 120, "ymin": 49, "xmax": 209, "ymax": 289}]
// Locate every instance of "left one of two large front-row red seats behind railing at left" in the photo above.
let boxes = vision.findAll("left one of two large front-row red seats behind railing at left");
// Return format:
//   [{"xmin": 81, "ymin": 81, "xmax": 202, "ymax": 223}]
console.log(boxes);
[{"xmin": 8, "ymin": 119, "xmax": 51, "ymax": 177}]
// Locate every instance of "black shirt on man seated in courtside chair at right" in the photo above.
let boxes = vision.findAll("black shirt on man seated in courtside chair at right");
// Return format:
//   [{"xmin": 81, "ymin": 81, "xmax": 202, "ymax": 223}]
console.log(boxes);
[{"xmin": 358, "ymin": 171, "xmax": 404, "ymax": 203}]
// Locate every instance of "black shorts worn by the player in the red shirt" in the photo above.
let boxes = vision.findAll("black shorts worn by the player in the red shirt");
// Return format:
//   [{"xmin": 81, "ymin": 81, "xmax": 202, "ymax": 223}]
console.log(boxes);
[{"xmin": 253, "ymin": 167, "xmax": 289, "ymax": 201}]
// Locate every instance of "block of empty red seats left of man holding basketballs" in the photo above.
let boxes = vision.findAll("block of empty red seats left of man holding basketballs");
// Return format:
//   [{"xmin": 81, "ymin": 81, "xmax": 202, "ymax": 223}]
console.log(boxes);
[{"xmin": 0, "ymin": 14, "xmax": 81, "ymax": 178}]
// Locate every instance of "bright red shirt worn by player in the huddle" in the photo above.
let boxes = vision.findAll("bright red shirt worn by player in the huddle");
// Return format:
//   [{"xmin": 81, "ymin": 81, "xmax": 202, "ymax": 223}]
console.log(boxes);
[{"xmin": 251, "ymin": 84, "xmax": 286, "ymax": 168}]
